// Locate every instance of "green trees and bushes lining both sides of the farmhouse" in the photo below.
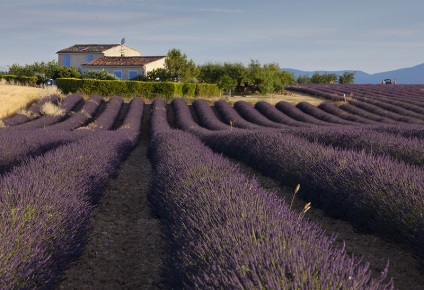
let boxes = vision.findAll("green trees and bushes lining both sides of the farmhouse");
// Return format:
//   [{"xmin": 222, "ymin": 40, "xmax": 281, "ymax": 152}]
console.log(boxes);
[{"xmin": 1, "ymin": 48, "xmax": 354, "ymax": 94}]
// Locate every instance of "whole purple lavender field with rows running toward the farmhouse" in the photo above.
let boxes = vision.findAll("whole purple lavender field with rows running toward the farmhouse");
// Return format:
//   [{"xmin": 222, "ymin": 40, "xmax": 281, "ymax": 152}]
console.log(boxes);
[{"xmin": 0, "ymin": 85, "xmax": 424, "ymax": 289}]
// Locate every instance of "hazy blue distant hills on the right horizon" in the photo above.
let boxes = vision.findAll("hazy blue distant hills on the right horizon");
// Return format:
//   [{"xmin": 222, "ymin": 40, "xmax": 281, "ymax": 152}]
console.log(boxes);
[{"xmin": 281, "ymin": 63, "xmax": 424, "ymax": 84}]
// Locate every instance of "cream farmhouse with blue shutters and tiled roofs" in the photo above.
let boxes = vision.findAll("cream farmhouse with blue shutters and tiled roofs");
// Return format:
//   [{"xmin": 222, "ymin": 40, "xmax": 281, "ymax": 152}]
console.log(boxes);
[{"xmin": 57, "ymin": 44, "xmax": 166, "ymax": 80}]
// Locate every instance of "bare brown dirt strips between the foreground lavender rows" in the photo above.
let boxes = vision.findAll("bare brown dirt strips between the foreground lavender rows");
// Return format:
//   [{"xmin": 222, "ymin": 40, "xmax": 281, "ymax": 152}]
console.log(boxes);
[{"xmin": 58, "ymin": 106, "xmax": 424, "ymax": 290}]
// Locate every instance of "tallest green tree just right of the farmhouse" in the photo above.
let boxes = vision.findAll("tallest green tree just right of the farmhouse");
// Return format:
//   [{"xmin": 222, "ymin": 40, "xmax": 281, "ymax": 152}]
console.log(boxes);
[{"xmin": 165, "ymin": 48, "xmax": 199, "ymax": 82}]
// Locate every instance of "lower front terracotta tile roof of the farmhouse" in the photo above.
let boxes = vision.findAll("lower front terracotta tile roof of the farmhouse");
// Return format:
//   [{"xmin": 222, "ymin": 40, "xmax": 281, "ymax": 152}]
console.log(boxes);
[{"xmin": 83, "ymin": 56, "xmax": 166, "ymax": 66}]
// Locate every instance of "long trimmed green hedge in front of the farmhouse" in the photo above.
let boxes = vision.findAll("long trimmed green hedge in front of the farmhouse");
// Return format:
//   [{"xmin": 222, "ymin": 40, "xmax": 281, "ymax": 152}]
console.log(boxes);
[{"xmin": 56, "ymin": 78, "xmax": 219, "ymax": 99}]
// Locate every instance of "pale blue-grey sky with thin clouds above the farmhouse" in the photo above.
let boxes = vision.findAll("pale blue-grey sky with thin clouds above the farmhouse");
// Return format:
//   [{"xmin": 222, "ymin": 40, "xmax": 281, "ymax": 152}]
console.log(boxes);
[{"xmin": 0, "ymin": 0, "xmax": 424, "ymax": 74}]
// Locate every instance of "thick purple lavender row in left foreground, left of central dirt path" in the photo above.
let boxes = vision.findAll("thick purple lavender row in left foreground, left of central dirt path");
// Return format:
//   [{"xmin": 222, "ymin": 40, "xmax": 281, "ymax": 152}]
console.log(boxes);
[{"xmin": 0, "ymin": 131, "xmax": 139, "ymax": 289}]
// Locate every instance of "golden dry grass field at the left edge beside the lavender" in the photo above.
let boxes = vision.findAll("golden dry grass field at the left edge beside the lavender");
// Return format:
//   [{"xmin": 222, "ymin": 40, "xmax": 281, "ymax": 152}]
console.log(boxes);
[{"xmin": 0, "ymin": 82, "xmax": 64, "ymax": 119}]
